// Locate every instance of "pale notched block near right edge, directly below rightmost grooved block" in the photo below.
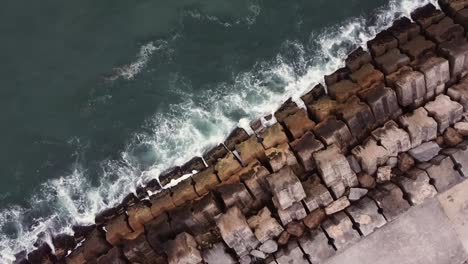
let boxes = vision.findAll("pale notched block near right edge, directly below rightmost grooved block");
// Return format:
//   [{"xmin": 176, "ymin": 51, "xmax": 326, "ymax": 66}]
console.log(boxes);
[{"xmin": 424, "ymin": 94, "xmax": 463, "ymax": 133}]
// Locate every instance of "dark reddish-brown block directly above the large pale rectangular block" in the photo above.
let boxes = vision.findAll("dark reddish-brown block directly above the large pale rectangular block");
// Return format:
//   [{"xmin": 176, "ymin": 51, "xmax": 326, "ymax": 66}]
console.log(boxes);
[{"xmin": 314, "ymin": 116, "xmax": 356, "ymax": 152}]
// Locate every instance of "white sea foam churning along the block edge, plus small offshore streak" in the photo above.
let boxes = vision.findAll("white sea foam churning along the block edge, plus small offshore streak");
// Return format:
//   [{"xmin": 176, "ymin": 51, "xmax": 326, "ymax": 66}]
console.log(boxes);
[{"xmin": 0, "ymin": 0, "xmax": 436, "ymax": 263}]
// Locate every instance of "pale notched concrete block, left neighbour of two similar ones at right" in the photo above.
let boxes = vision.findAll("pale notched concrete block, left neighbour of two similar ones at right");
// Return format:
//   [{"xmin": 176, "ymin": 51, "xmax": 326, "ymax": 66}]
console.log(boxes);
[{"xmin": 372, "ymin": 120, "xmax": 411, "ymax": 157}]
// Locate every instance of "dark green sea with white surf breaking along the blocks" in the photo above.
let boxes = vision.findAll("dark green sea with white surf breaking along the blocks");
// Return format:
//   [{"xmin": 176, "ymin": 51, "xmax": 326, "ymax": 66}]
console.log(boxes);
[{"xmin": 0, "ymin": 0, "xmax": 435, "ymax": 263}]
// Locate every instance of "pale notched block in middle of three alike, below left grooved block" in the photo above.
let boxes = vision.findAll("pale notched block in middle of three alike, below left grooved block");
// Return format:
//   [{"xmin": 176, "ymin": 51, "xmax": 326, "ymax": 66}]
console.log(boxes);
[{"xmin": 399, "ymin": 107, "xmax": 437, "ymax": 148}]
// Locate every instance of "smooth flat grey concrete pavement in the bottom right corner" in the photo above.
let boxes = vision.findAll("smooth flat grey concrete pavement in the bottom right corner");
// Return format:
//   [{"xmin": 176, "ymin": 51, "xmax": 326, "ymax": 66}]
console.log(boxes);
[{"xmin": 326, "ymin": 198, "xmax": 468, "ymax": 264}]
